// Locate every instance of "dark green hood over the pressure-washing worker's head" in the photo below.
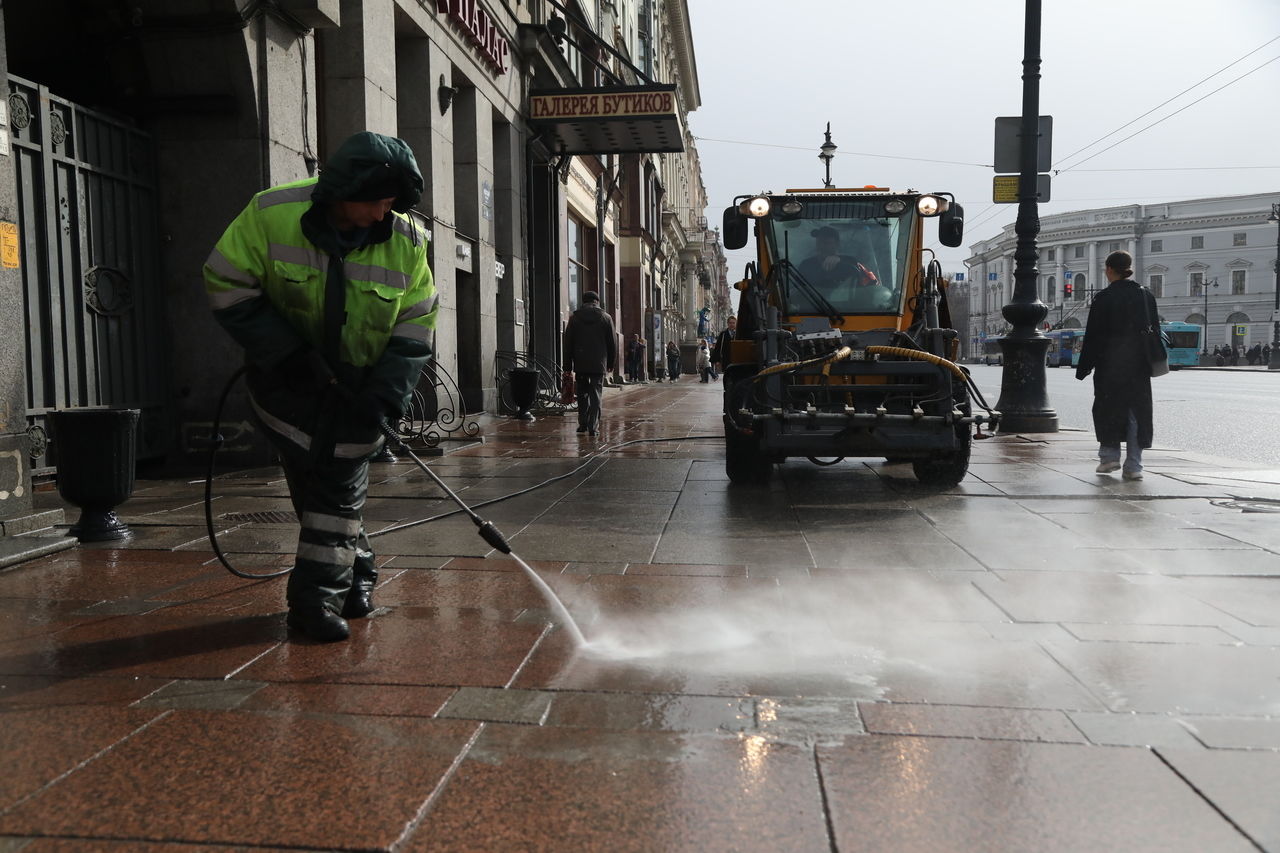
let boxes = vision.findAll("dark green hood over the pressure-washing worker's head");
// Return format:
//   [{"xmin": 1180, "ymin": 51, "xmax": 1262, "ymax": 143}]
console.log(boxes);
[{"xmin": 311, "ymin": 131, "xmax": 422, "ymax": 213}]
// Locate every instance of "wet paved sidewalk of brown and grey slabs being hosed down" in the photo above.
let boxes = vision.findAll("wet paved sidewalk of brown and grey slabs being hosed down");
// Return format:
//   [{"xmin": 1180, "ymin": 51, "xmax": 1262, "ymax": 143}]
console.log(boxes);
[{"xmin": 0, "ymin": 382, "xmax": 1280, "ymax": 853}]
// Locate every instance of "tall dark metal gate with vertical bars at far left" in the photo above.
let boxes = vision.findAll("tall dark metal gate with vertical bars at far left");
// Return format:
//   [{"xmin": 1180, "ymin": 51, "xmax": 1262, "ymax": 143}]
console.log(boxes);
[{"xmin": 8, "ymin": 77, "xmax": 168, "ymax": 474}]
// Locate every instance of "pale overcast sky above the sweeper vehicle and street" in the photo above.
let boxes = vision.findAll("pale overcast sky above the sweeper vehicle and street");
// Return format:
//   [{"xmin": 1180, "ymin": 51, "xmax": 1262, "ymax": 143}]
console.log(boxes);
[{"xmin": 689, "ymin": 0, "xmax": 1280, "ymax": 280}]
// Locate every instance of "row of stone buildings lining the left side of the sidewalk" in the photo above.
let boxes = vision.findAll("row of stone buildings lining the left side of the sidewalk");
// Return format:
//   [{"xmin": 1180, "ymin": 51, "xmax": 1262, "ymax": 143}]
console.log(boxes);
[{"xmin": 0, "ymin": 0, "xmax": 728, "ymax": 519}]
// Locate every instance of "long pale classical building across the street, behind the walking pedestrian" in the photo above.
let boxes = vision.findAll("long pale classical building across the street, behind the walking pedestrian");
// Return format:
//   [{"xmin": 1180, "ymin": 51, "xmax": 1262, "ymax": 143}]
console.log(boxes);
[{"xmin": 952, "ymin": 191, "xmax": 1280, "ymax": 360}]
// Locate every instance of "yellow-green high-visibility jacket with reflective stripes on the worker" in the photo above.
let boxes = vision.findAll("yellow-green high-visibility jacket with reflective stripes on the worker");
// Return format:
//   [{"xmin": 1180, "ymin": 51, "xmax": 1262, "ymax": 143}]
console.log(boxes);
[{"xmin": 204, "ymin": 178, "xmax": 438, "ymax": 411}]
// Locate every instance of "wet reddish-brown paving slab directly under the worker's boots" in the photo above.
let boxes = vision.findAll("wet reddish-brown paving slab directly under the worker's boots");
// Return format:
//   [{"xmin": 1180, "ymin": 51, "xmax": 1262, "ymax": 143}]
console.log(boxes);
[{"xmin": 238, "ymin": 608, "xmax": 545, "ymax": 686}]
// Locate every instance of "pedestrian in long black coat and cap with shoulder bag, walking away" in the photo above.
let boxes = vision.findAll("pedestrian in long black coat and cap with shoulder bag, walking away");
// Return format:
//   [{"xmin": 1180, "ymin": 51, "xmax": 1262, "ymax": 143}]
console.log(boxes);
[{"xmin": 1075, "ymin": 252, "xmax": 1160, "ymax": 480}]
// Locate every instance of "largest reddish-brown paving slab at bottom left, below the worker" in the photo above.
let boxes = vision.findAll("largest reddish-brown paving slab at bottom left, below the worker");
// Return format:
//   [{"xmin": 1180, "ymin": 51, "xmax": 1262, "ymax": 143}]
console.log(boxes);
[{"xmin": 0, "ymin": 711, "xmax": 475, "ymax": 849}]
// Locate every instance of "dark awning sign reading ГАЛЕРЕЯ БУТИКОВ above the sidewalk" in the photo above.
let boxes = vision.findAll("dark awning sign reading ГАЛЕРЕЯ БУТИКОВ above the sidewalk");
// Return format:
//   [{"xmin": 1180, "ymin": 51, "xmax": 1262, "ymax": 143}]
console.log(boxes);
[{"xmin": 529, "ymin": 86, "xmax": 685, "ymax": 154}]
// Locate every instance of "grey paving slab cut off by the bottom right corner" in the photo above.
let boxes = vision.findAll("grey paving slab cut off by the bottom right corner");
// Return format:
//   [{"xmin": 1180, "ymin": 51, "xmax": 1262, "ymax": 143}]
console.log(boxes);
[{"xmin": 1160, "ymin": 749, "xmax": 1280, "ymax": 850}]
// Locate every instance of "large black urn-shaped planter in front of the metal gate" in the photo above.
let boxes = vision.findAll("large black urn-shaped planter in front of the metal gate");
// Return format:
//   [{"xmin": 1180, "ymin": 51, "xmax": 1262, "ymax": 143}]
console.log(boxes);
[{"xmin": 49, "ymin": 409, "xmax": 142, "ymax": 542}]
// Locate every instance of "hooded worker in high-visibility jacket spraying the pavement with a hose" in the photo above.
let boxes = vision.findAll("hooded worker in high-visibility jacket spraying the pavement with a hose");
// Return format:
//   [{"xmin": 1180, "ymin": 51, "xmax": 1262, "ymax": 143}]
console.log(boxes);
[{"xmin": 204, "ymin": 133, "xmax": 436, "ymax": 642}]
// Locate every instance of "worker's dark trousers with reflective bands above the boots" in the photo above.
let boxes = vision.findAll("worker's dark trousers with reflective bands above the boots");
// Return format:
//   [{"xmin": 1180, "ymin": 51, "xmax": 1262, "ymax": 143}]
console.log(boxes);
[{"xmin": 268, "ymin": 430, "xmax": 378, "ymax": 613}]
